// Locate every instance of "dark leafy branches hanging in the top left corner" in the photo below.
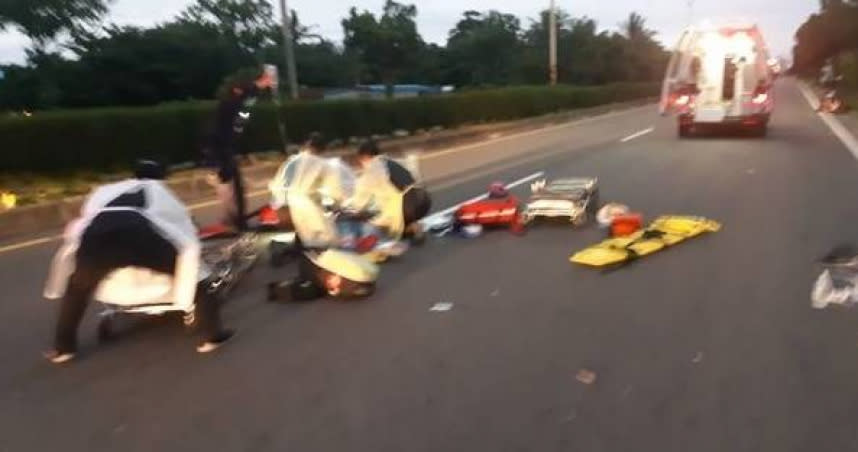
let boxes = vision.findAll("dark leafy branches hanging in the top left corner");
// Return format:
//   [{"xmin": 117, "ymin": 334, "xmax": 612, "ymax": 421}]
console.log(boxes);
[{"xmin": 0, "ymin": 0, "xmax": 111, "ymax": 44}]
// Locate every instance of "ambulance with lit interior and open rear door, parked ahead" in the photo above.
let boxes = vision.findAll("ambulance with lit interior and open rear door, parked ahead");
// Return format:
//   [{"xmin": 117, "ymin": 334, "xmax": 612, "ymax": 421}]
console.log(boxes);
[{"xmin": 660, "ymin": 24, "xmax": 774, "ymax": 137}]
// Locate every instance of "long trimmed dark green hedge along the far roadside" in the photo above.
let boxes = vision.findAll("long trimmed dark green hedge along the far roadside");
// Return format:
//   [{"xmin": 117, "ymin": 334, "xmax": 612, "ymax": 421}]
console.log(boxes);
[{"xmin": 0, "ymin": 83, "xmax": 658, "ymax": 173}]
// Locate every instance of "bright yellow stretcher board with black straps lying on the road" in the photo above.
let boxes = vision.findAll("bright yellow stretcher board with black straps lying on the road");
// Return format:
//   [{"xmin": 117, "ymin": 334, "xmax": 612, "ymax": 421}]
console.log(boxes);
[{"xmin": 569, "ymin": 216, "xmax": 721, "ymax": 267}]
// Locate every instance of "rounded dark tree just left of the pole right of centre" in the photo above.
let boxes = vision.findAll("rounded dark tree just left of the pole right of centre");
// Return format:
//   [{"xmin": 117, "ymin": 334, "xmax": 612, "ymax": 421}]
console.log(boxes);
[{"xmin": 446, "ymin": 11, "xmax": 521, "ymax": 85}]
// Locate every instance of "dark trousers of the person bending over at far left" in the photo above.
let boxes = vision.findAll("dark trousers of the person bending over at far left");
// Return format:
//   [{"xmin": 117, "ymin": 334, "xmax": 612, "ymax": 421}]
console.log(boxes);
[{"xmin": 54, "ymin": 212, "xmax": 222, "ymax": 353}]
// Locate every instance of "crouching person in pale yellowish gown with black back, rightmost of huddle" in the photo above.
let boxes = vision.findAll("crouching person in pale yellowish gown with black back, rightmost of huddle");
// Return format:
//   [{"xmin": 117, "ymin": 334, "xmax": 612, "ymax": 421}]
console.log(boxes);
[{"xmin": 347, "ymin": 140, "xmax": 432, "ymax": 243}]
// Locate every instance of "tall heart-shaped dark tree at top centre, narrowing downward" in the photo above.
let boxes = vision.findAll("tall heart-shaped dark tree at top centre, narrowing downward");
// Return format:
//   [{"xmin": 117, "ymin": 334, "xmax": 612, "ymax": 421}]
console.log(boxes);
[{"xmin": 342, "ymin": 0, "xmax": 424, "ymax": 97}]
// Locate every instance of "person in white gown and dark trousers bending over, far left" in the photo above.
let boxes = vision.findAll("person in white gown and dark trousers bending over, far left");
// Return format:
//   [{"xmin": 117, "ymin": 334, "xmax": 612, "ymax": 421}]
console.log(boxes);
[{"xmin": 44, "ymin": 161, "xmax": 233, "ymax": 363}]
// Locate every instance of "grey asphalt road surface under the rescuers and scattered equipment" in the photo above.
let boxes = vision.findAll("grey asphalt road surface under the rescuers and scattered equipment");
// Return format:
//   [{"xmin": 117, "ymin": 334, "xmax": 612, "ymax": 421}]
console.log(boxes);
[{"xmin": 0, "ymin": 80, "xmax": 858, "ymax": 452}]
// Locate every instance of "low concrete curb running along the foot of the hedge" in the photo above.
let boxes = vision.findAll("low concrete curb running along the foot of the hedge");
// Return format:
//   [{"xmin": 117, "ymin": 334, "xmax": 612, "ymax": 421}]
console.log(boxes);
[{"xmin": 0, "ymin": 98, "xmax": 653, "ymax": 242}]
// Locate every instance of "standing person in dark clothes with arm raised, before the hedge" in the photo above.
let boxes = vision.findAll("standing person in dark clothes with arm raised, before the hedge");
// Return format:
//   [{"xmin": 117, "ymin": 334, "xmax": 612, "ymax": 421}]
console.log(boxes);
[{"xmin": 204, "ymin": 71, "xmax": 277, "ymax": 230}]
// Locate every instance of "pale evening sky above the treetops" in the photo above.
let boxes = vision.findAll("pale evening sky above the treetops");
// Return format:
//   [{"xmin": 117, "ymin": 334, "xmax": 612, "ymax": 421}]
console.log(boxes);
[{"xmin": 0, "ymin": 0, "xmax": 819, "ymax": 63}]
